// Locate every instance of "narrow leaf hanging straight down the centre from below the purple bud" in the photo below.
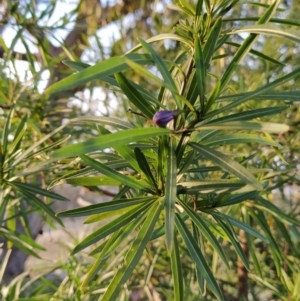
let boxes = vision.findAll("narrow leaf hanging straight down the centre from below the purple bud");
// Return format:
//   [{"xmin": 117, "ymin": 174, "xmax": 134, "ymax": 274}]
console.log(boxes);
[{"xmin": 165, "ymin": 137, "xmax": 177, "ymax": 253}]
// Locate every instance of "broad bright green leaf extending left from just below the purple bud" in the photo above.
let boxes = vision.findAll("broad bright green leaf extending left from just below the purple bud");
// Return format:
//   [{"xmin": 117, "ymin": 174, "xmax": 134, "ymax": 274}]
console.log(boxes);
[{"xmin": 52, "ymin": 128, "xmax": 171, "ymax": 158}]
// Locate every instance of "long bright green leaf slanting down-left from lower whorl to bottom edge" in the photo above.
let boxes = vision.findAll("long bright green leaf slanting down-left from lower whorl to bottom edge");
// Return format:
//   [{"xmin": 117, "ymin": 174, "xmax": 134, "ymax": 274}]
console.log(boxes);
[{"xmin": 101, "ymin": 202, "xmax": 161, "ymax": 301}]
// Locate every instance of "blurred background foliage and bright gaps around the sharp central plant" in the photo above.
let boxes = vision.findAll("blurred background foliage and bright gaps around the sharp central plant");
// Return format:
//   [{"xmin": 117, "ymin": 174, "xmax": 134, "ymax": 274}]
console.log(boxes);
[{"xmin": 0, "ymin": 0, "xmax": 300, "ymax": 301}]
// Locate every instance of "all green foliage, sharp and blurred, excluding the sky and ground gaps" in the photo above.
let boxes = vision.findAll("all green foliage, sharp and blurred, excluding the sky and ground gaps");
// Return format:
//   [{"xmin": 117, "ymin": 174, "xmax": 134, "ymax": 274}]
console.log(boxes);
[{"xmin": 0, "ymin": 0, "xmax": 300, "ymax": 301}]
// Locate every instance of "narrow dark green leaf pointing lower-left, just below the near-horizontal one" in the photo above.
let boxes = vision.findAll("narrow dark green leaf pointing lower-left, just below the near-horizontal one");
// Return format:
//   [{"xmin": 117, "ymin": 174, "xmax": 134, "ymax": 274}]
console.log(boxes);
[{"xmin": 72, "ymin": 202, "xmax": 153, "ymax": 255}]
